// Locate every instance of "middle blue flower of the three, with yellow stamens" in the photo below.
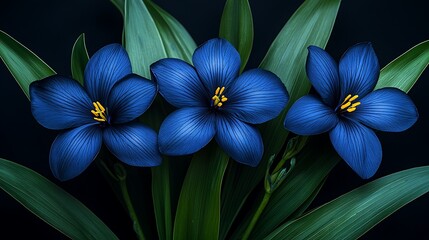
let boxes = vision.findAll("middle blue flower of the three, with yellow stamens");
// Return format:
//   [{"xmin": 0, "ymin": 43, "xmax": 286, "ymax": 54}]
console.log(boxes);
[{"xmin": 151, "ymin": 39, "xmax": 288, "ymax": 166}]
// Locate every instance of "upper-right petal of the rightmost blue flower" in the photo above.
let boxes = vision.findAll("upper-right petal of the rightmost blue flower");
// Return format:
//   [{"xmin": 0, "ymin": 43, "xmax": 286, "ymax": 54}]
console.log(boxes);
[{"xmin": 340, "ymin": 43, "xmax": 380, "ymax": 100}]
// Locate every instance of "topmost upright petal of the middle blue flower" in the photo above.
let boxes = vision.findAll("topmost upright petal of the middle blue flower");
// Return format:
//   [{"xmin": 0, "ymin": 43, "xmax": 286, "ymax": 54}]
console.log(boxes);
[{"xmin": 192, "ymin": 38, "xmax": 241, "ymax": 94}]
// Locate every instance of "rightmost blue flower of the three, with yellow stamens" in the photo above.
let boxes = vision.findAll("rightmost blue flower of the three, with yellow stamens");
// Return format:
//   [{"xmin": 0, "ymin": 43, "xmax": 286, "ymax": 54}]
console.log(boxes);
[{"xmin": 285, "ymin": 43, "xmax": 418, "ymax": 179}]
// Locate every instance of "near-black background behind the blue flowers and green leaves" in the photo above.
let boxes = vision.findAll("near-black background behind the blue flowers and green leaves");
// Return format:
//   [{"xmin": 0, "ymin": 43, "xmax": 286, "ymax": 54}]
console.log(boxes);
[{"xmin": 0, "ymin": 0, "xmax": 429, "ymax": 239}]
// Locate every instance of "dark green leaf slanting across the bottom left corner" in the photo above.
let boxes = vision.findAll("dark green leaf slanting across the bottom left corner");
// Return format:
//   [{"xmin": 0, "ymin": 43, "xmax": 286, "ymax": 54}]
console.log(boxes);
[{"xmin": 0, "ymin": 158, "xmax": 118, "ymax": 239}]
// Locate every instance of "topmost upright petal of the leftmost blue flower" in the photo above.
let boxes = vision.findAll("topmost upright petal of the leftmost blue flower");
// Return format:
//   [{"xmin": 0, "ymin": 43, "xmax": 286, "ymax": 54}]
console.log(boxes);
[{"xmin": 84, "ymin": 44, "xmax": 131, "ymax": 105}]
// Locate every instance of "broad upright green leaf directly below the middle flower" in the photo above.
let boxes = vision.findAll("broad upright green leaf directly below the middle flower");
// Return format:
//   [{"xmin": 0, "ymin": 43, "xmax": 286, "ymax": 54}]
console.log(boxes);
[{"xmin": 173, "ymin": 142, "xmax": 229, "ymax": 240}]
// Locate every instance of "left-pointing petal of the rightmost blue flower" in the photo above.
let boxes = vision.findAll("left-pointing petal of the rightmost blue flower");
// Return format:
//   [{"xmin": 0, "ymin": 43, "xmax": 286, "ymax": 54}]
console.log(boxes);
[{"xmin": 284, "ymin": 95, "xmax": 338, "ymax": 135}]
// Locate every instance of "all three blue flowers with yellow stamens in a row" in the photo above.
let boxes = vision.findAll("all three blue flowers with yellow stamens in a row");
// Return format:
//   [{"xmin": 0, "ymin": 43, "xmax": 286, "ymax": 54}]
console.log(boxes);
[{"xmin": 30, "ymin": 39, "xmax": 418, "ymax": 180}]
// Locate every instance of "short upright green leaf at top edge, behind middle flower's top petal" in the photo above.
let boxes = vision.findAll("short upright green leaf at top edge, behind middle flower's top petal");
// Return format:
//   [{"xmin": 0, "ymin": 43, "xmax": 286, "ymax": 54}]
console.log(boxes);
[{"xmin": 219, "ymin": 0, "xmax": 253, "ymax": 71}]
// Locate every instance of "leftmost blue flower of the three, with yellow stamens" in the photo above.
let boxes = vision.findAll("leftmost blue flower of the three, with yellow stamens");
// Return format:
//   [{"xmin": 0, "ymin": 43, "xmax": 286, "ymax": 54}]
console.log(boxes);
[{"xmin": 30, "ymin": 44, "xmax": 161, "ymax": 181}]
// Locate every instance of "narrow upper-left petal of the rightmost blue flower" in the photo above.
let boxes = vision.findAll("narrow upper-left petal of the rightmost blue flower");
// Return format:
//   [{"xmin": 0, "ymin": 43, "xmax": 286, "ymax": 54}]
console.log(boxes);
[{"xmin": 306, "ymin": 46, "xmax": 340, "ymax": 107}]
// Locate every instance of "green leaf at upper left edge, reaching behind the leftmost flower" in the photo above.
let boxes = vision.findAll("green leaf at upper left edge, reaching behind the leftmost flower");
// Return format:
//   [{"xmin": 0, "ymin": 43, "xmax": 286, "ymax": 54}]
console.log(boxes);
[{"xmin": 0, "ymin": 30, "xmax": 55, "ymax": 99}]
